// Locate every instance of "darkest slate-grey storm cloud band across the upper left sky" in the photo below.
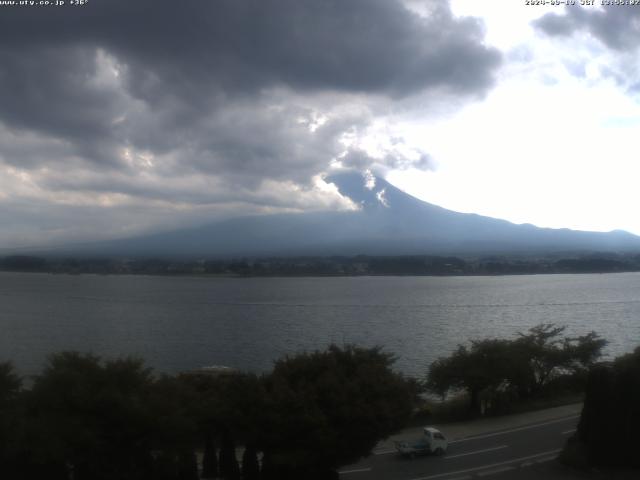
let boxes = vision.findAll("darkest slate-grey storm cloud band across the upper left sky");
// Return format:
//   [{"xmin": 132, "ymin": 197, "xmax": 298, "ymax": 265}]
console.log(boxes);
[{"xmin": 0, "ymin": 0, "xmax": 499, "ymax": 167}]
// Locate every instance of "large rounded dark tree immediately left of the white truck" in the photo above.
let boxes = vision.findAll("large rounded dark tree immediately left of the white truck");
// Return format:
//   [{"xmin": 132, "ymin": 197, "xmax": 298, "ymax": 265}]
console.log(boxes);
[{"xmin": 260, "ymin": 345, "xmax": 414, "ymax": 479}]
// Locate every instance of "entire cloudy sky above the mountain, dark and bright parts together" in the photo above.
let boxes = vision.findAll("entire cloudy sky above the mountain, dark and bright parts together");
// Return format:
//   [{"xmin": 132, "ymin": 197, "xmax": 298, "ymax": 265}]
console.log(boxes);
[{"xmin": 0, "ymin": 0, "xmax": 640, "ymax": 247}]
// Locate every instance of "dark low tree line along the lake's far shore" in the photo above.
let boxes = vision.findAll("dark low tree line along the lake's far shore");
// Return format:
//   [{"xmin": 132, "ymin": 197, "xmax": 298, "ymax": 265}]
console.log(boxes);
[{"xmin": 0, "ymin": 253, "xmax": 640, "ymax": 276}]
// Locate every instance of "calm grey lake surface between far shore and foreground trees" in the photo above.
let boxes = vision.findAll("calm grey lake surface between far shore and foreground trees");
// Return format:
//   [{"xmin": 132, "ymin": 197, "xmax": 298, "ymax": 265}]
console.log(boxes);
[{"xmin": 0, "ymin": 272, "xmax": 640, "ymax": 377}]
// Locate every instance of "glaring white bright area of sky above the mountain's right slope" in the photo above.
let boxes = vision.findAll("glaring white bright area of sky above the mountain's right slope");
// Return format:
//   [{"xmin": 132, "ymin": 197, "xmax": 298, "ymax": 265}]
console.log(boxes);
[{"xmin": 388, "ymin": 2, "xmax": 640, "ymax": 234}]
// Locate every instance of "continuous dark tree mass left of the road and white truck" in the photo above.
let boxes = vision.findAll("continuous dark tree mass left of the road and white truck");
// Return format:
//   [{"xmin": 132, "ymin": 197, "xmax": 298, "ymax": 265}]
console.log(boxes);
[{"xmin": 0, "ymin": 346, "xmax": 416, "ymax": 480}]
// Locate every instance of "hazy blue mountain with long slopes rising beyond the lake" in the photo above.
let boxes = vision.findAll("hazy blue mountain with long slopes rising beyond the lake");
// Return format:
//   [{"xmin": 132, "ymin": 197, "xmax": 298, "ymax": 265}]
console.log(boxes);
[{"xmin": 41, "ymin": 172, "xmax": 640, "ymax": 257}]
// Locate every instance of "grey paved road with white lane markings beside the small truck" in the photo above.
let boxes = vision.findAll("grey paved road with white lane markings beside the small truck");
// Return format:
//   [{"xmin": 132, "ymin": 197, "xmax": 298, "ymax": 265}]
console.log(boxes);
[{"xmin": 340, "ymin": 414, "xmax": 579, "ymax": 480}]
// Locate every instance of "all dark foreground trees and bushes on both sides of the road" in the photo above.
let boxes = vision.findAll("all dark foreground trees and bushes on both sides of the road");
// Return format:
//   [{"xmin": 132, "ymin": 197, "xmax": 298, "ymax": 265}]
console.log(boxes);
[{"xmin": 0, "ymin": 324, "xmax": 640, "ymax": 480}]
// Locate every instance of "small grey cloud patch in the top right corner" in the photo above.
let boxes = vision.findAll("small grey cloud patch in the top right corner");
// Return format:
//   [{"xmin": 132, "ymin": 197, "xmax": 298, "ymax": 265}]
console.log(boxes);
[{"xmin": 534, "ymin": 5, "xmax": 640, "ymax": 51}]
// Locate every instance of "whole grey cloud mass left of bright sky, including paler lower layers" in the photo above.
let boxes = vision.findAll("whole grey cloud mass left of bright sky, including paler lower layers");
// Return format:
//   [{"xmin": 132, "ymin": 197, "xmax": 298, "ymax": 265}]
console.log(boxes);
[{"xmin": 0, "ymin": 0, "xmax": 501, "ymax": 246}]
